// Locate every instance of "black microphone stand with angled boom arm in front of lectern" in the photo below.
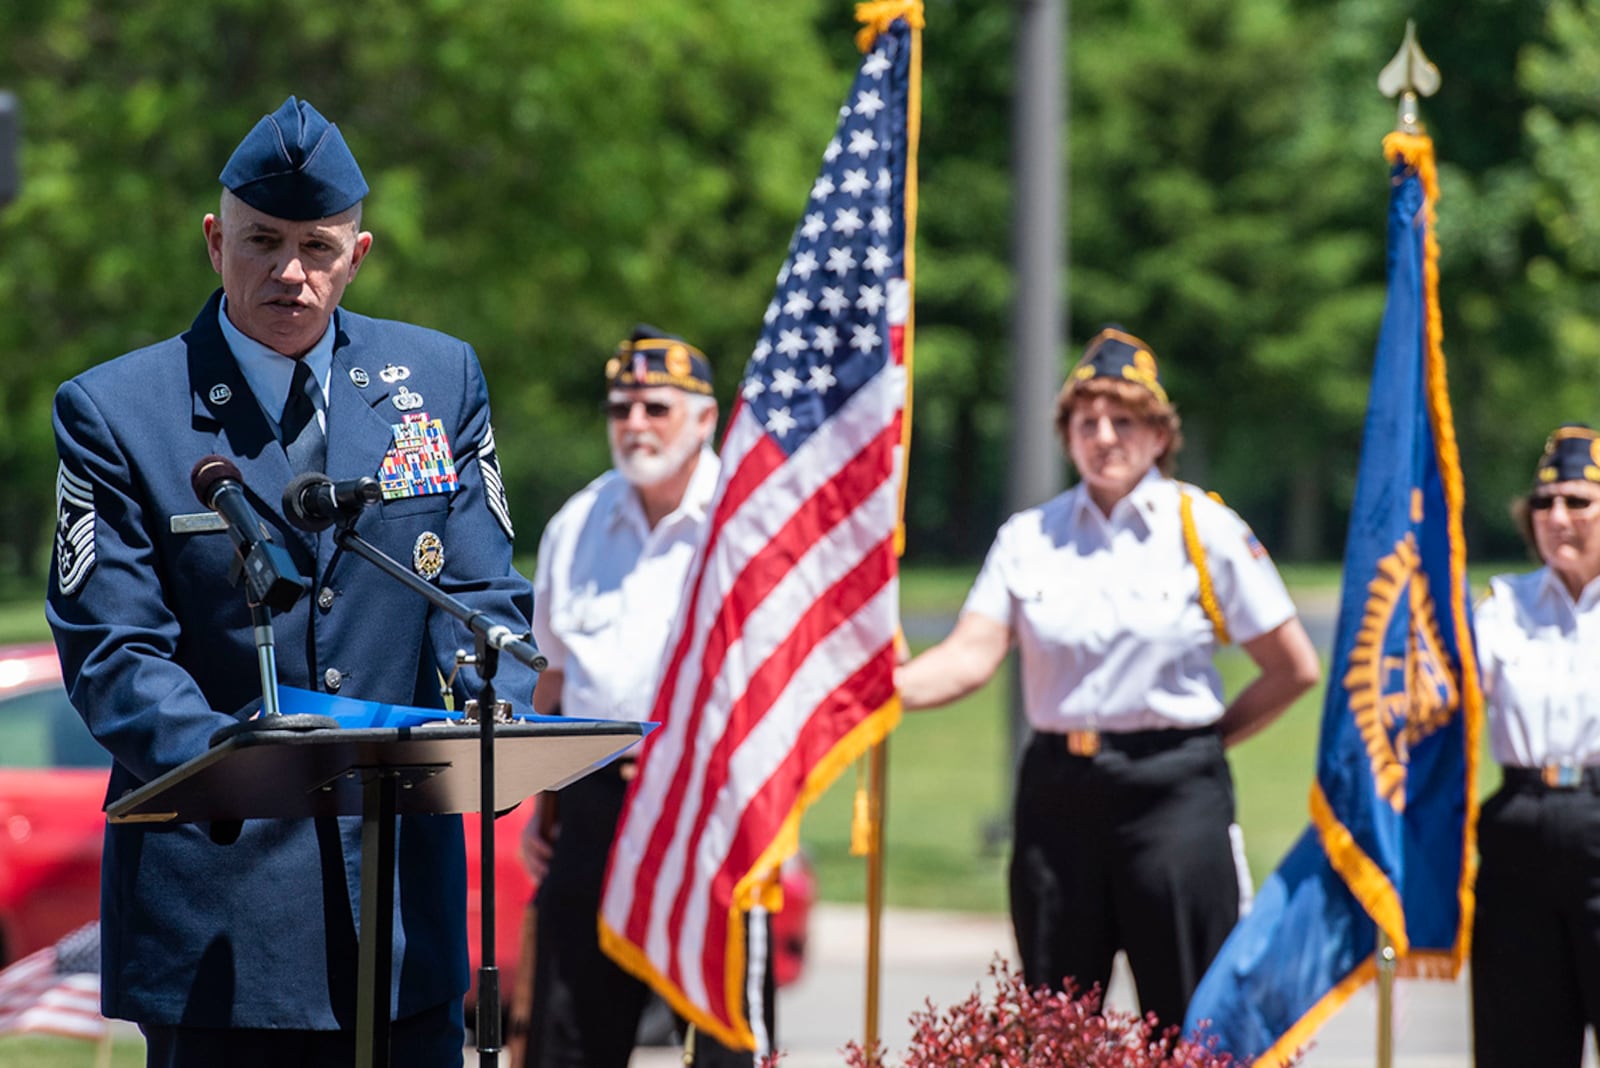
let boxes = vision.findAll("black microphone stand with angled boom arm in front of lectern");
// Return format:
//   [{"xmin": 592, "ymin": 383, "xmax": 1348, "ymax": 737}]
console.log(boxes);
[{"xmin": 333, "ymin": 516, "xmax": 547, "ymax": 1068}]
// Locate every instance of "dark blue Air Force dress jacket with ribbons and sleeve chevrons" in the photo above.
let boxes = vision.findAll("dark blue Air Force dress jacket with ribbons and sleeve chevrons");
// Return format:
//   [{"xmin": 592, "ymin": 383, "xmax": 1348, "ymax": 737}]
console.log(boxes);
[{"xmin": 48, "ymin": 293, "xmax": 534, "ymax": 1030}]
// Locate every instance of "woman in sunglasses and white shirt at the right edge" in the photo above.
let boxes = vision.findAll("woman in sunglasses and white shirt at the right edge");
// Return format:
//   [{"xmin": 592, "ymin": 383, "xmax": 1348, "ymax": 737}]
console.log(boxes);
[{"xmin": 1472, "ymin": 425, "xmax": 1600, "ymax": 1068}]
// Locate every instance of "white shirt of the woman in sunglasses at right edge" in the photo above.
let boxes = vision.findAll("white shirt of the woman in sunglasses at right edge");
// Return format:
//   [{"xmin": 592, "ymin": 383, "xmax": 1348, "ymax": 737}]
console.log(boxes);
[{"xmin": 1472, "ymin": 568, "xmax": 1600, "ymax": 767}]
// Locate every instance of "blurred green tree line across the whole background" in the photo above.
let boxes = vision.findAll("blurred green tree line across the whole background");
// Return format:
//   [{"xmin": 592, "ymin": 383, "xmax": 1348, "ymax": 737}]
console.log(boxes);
[{"xmin": 0, "ymin": 0, "xmax": 1600, "ymax": 593}]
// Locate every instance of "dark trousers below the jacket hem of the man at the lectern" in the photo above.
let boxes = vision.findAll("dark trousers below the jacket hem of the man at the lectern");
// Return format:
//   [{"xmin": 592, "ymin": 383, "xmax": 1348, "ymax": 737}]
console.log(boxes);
[{"xmin": 139, "ymin": 1001, "xmax": 467, "ymax": 1068}]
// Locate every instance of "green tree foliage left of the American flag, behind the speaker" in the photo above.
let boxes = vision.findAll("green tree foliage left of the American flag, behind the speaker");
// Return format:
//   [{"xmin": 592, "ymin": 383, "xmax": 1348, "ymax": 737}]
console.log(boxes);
[{"xmin": 0, "ymin": 0, "xmax": 854, "ymax": 585}]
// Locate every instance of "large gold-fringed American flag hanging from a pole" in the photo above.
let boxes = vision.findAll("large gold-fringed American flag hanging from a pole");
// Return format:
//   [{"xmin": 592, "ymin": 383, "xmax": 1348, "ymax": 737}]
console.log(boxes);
[{"xmin": 600, "ymin": 0, "xmax": 922, "ymax": 1049}]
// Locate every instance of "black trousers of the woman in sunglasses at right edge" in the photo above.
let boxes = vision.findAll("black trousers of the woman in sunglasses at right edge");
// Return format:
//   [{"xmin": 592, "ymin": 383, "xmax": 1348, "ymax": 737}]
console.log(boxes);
[{"xmin": 1472, "ymin": 769, "xmax": 1600, "ymax": 1068}]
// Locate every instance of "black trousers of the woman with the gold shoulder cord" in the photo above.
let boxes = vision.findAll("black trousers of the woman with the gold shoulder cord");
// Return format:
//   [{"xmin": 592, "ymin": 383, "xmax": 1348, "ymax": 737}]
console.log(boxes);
[{"xmin": 1011, "ymin": 731, "xmax": 1240, "ymax": 1028}]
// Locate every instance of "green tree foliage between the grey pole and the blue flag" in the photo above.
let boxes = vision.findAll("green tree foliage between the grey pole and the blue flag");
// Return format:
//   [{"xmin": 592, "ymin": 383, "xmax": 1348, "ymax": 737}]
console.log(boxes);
[{"xmin": 1072, "ymin": 0, "xmax": 1392, "ymax": 556}]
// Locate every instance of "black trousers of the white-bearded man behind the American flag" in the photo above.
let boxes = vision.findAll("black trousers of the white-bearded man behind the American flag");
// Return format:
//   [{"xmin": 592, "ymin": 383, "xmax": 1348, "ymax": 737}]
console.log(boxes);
[{"xmin": 525, "ymin": 767, "xmax": 776, "ymax": 1068}]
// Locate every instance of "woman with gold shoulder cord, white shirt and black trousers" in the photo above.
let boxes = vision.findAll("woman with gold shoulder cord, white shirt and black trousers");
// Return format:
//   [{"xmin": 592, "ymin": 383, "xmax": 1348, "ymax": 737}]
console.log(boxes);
[{"xmin": 898, "ymin": 328, "xmax": 1320, "ymax": 1026}]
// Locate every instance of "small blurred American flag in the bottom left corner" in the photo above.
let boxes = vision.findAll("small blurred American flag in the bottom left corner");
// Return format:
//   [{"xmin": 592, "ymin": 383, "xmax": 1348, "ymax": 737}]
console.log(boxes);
[{"xmin": 0, "ymin": 921, "xmax": 107, "ymax": 1039}]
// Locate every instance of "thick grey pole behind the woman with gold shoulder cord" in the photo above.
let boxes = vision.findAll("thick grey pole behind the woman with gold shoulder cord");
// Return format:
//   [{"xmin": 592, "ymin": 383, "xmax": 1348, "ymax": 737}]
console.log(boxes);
[{"xmin": 1006, "ymin": 0, "xmax": 1067, "ymax": 767}]
